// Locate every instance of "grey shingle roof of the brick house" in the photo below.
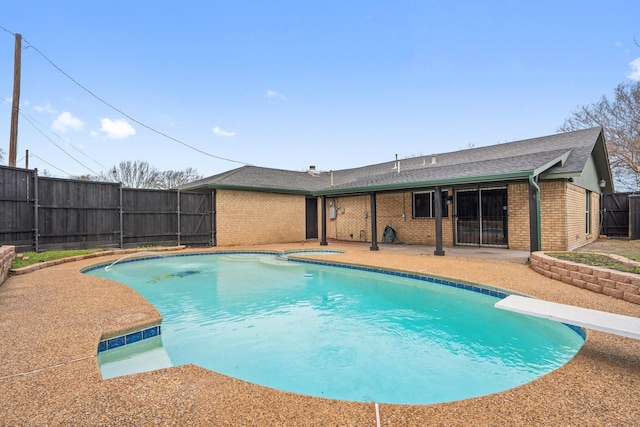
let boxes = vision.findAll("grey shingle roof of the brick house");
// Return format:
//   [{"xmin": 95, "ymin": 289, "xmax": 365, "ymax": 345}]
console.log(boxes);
[{"xmin": 181, "ymin": 127, "xmax": 608, "ymax": 195}]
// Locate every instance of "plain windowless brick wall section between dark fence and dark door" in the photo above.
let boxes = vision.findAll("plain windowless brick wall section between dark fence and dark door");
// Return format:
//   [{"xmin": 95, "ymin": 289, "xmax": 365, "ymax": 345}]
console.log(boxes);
[{"xmin": 216, "ymin": 190, "xmax": 306, "ymax": 246}]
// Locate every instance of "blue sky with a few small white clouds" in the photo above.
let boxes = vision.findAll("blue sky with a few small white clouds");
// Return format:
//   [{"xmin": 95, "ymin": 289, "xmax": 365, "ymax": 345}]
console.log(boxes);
[{"xmin": 0, "ymin": 0, "xmax": 640, "ymax": 178}]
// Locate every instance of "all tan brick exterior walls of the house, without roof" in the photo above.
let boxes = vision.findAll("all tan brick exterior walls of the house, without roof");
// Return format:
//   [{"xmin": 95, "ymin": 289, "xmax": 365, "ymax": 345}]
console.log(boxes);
[{"xmin": 211, "ymin": 180, "xmax": 600, "ymax": 251}]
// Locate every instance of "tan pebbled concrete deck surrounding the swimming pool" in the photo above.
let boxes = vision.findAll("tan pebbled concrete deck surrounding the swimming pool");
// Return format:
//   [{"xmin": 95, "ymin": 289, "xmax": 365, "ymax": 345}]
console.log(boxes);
[{"xmin": 0, "ymin": 242, "xmax": 640, "ymax": 426}]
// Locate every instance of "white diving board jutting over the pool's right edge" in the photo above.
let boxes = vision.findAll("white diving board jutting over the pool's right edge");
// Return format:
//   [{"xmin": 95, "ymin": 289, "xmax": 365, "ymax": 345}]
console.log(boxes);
[{"xmin": 495, "ymin": 295, "xmax": 640, "ymax": 340}]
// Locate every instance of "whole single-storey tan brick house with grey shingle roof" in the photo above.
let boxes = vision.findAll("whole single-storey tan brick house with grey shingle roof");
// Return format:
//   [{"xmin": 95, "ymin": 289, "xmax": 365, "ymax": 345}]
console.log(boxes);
[{"xmin": 180, "ymin": 127, "xmax": 613, "ymax": 254}]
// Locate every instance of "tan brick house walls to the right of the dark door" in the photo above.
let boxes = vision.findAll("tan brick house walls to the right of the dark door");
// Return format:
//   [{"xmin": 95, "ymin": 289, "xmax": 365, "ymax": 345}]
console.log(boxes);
[{"xmin": 320, "ymin": 180, "xmax": 600, "ymax": 251}]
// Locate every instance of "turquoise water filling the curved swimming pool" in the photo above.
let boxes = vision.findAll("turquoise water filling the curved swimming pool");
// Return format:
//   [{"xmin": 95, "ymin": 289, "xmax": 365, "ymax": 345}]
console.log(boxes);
[{"xmin": 88, "ymin": 254, "xmax": 584, "ymax": 404}]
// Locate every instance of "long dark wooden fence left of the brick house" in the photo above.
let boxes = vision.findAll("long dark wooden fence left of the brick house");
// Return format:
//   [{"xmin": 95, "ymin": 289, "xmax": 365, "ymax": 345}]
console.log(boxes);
[{"xmin": 0, "ymin": 167, "xmax": 214, "ymax": 252}]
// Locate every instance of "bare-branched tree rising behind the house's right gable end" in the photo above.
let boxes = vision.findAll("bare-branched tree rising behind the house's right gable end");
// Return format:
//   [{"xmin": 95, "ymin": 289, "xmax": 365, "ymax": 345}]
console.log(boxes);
[{"xmin": 559, "ymin": 82, "xmax": 640, "ymax": 190}]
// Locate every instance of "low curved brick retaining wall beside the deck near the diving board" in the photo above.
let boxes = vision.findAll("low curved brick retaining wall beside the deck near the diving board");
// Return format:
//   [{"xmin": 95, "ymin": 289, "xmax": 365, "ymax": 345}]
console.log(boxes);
[{"xmin": 530, "ymin": 252, "xmax": 640, "ymax": 304}]
